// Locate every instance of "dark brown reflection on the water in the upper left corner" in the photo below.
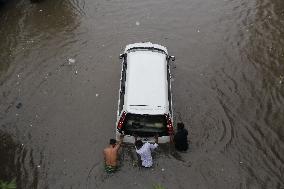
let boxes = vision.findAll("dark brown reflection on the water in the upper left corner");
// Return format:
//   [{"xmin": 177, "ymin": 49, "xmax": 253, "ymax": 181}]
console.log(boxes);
[{"xmin": 0, "ymin": 0, "xmax": 77, "ymax": 80}]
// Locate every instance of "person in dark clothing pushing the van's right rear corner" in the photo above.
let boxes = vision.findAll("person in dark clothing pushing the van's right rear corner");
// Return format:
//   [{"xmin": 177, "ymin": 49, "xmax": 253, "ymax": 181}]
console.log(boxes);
[{"xmin": 174, "ymin": 122, "xmax": 188, "ymax": 151}]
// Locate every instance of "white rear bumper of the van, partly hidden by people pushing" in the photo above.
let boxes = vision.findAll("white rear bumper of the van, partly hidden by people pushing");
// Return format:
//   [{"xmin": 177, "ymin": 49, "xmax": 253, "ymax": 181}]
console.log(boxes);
[{"xmin": 116, "ymin": 131, "xmax": 170, "ymax": 144}]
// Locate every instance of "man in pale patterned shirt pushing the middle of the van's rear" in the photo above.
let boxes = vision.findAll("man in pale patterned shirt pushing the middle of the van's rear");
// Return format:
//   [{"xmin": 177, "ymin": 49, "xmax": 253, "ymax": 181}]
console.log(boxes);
[{"xmin": 135, "ymin": 135, "xmax": 158, "ymax": 167}]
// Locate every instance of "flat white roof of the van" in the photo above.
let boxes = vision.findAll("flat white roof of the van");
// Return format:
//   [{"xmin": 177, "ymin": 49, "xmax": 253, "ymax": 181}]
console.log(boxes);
[{"xmin": 125, "ymin": 50, "xmax": 169, "ymax": 114}]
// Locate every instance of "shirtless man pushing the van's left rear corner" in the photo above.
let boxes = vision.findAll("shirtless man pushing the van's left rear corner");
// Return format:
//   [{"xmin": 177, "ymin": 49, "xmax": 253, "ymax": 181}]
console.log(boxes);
[{"xmin": 104, "ymin": 135, "xmax": 124, "ymax": 173}]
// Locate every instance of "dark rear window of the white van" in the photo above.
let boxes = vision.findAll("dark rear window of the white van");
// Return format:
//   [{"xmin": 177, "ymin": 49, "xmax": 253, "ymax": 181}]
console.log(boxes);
[{"xmin": 123, "ymin": 113, "xmax": 168, "ymax": 136}]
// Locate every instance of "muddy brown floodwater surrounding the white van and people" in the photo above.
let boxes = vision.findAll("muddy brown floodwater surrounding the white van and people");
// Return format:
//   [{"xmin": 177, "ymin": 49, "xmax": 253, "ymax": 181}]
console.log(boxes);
[{"xmin": 0, "ymin": 0, "xmax": 284, "ymax": 189}]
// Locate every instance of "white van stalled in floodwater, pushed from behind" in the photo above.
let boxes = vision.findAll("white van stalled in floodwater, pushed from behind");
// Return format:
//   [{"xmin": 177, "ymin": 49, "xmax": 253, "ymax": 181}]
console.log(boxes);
[{"xmin": 116, "ymin": 42, "xmax": 175, "ymax": 143}]
